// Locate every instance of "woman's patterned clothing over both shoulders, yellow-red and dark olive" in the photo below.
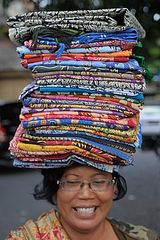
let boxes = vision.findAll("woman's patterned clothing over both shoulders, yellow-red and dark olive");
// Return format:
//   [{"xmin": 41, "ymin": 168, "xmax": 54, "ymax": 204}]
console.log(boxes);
[{"xmin": 5, "ymin": 209, "xmax": 160, "ymax": 240}]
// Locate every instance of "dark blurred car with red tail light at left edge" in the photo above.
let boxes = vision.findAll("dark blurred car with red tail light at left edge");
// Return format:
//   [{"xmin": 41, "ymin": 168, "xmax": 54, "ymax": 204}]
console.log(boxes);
[{"xmin": 0, "ymin": 101, "xmax": 21, "ymax": 167}]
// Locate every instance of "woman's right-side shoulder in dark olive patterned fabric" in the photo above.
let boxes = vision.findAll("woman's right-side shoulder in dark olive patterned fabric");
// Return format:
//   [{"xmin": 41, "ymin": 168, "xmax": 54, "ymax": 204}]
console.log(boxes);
[{"xmin": 110, "ymin": 219, "xmax": 160, "ymax": 240}]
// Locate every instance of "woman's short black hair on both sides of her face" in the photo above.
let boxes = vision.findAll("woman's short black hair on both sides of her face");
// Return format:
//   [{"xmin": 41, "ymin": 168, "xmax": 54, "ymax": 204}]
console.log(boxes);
[{"xmin": 33, "ymin": 168, "xmax": 127, "ymax": 205}]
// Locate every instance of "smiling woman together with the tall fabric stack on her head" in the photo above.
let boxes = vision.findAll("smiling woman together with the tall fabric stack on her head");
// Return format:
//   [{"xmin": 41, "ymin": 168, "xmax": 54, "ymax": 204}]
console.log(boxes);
[{"xmin": 6, "ymin": 8, "xmax": 160, "ymax": 240}]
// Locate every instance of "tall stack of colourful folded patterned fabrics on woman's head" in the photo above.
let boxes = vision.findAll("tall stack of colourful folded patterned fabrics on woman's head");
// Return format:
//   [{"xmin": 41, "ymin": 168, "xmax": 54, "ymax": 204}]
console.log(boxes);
[{"xmin": 8, "ymin": 8, "xmax": 145, "ymax": 172}]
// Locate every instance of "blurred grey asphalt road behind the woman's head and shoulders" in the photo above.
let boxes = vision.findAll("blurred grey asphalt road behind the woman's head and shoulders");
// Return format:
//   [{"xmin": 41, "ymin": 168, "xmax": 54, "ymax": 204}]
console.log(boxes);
[{"xmin": 0, "ymin": 151, "xmax": 160, "ymax": 240}]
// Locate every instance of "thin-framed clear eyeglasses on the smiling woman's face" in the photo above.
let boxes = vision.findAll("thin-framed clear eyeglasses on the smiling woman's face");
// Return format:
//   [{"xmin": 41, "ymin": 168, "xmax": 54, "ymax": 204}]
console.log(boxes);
[{"xmin": 57, "ymin": 178, "xmax": 116, "ymax": 192}]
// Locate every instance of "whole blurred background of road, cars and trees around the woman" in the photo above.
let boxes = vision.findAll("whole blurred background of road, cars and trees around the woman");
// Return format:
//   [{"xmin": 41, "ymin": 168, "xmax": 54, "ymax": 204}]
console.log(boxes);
[{"xmin": 0, "ymin": 0, "xmax": 160, "ymax": 239}]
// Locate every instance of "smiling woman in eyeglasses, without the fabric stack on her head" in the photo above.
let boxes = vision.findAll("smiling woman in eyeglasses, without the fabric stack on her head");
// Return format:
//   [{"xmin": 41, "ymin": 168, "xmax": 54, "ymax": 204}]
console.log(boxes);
[{"xmin": 6, "ymin": 164, "xmax": 160, "ymax": 240}]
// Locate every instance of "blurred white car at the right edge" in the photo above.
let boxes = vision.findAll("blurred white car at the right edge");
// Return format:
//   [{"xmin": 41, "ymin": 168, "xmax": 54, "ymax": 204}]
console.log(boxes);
[{"xmin": 140, "ymin": 99, "xmax": 160, "ymax": 157}]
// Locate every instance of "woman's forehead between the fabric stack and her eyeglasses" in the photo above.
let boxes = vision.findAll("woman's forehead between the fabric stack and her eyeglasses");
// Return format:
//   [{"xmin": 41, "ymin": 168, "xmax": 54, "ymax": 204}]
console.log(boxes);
[{"xmin": 63, "ymin": 165, "xmax": 112, "ymax": 177}]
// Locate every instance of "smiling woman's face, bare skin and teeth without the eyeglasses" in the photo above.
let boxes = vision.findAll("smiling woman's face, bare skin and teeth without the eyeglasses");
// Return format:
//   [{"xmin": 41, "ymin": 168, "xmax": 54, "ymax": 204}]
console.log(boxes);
[{"xmin": 57, "ymin": 166, "xmax": 115, "ymax": 232}]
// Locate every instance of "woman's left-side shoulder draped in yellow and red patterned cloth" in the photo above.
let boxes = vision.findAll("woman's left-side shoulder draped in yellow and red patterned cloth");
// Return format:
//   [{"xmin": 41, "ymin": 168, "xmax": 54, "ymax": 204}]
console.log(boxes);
[{"xmin": 5, "ymin": 209, "xmax": 56, "ymax": 240}]
